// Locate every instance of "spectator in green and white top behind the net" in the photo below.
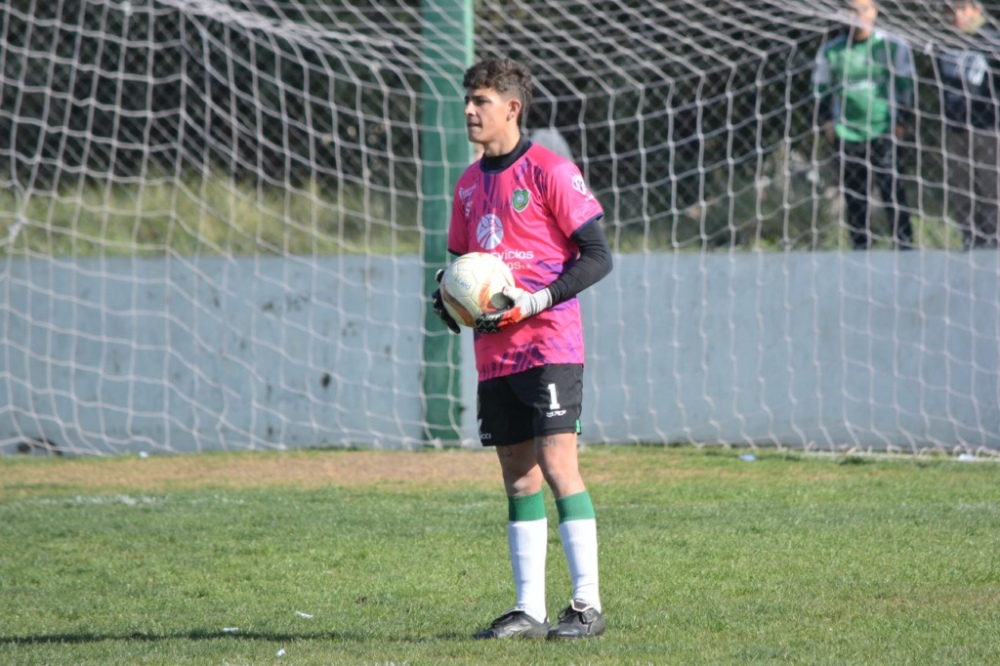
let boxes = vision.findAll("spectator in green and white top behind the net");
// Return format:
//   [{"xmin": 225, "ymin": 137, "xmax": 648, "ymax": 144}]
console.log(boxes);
[{"xmin": 813, "ymin": 0, "xmax": 913, "ymax": 250}]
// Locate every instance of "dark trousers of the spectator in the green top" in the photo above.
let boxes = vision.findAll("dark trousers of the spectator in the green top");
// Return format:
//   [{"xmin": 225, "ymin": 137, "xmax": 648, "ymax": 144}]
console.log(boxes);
[{"xmin": 840, "ymin": 136, "xmax": 913, "ymax": 250}]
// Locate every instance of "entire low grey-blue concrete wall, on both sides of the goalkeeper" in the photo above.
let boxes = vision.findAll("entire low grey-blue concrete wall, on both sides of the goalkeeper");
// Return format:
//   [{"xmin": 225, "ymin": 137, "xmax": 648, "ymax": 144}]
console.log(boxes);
[{"xmin": 0, "ymin": 252, "xmax": 1000, "ymax": 453}]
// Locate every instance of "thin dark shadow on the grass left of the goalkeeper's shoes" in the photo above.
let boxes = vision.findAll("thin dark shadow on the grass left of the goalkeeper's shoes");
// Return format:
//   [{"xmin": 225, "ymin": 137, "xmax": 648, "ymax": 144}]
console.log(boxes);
[{"xmin": 0, "ymin": 630, "xmax": 467, "ymax": 645}]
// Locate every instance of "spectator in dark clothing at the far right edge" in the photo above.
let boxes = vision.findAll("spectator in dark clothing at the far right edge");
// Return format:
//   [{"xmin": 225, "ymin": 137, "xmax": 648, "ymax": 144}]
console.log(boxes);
[{"xmin": 938, "ymin": 0, "xmax": 1000, "ymax": 249}]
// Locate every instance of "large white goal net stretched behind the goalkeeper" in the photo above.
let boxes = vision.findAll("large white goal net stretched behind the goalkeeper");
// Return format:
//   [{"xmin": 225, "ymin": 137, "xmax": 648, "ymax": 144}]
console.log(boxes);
[{"xmin": 0, "ymin": 0, "xmax": 1000, "ymax": 454}]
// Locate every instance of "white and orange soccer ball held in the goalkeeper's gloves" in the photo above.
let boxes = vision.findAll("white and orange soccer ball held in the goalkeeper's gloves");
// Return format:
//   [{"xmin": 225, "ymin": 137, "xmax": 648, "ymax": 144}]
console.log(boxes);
[{"xmin": 441, "ymin": 252, "xmax": 514, "ymax": 326}]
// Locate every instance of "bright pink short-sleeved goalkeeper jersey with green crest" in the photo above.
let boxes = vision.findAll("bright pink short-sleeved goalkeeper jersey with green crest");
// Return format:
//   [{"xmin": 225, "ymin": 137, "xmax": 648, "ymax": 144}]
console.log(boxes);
[{"xmin": 448, "ymin": 144, "xmax": 604, "ymax": 381}]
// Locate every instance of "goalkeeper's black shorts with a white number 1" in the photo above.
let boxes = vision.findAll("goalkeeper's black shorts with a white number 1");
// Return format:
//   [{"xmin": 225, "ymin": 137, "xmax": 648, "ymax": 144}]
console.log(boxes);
[{"xmin": 476, "ymin": 364, "xmax": 583, "ymax": 446}]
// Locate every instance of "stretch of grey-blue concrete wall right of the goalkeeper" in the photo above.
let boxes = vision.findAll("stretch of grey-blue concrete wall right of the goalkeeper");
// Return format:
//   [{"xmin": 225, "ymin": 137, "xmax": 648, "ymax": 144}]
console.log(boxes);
[{"xmin": 585, "ymin": 252, "xmax": 1000, "ymax": 450}]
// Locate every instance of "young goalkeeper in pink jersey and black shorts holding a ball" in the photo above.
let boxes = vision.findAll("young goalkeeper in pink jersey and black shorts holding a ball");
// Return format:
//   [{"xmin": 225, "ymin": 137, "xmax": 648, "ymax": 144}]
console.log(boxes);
[{"xmin": 431, "ymin": 59, "xmax": 612, "ymax": 638}]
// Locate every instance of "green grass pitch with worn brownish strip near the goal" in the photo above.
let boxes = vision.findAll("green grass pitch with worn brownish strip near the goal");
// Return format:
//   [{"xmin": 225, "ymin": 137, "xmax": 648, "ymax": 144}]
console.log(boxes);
[{"xmin": 0, "ymin": 447, "xmax": 1000, "ymax": 666}]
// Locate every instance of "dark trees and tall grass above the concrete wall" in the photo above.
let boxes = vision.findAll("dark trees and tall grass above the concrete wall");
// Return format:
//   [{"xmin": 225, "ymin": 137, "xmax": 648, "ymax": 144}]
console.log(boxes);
[{"xmin": 0, "ymin": 0, "xmax": 976, "ymax": 255}]
